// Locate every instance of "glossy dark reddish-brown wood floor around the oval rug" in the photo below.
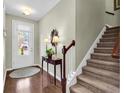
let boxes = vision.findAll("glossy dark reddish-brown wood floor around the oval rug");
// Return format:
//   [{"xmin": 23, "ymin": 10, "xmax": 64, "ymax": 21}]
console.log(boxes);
[{"xmin": 4, "ymin": 67, "xmax": 61, "ymax": 93}]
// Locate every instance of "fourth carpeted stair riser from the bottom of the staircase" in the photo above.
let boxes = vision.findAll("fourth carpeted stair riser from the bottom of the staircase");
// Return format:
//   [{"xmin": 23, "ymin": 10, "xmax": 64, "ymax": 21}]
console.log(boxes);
[{"xmin": 88, "ymin": 62, "xmax": 119, "ymax": 73}]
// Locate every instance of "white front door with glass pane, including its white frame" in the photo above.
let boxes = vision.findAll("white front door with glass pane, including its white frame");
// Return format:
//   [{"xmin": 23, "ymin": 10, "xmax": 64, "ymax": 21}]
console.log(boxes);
[{"xmin": 12, "ymin": 20, "xmax": 34, "ymax": 69}]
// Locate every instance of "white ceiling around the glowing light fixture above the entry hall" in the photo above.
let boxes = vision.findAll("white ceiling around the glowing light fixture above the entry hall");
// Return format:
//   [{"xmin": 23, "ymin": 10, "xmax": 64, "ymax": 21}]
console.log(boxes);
[{"xmin": 4, "ymin": 0, "xmax": 60, "ymax": 21}]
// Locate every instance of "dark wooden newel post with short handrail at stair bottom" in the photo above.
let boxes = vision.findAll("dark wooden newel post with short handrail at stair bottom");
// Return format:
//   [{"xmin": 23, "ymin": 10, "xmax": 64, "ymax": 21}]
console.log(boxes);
[{"xmin": 61, "ymin": 40, "xmax": 75, "ymax": 93}]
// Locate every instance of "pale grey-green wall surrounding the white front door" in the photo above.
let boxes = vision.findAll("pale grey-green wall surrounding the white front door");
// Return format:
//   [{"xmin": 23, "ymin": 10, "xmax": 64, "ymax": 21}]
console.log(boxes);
[{"xmin": 5, "ymin": 14, "xmax": 40, "ymax": 69}]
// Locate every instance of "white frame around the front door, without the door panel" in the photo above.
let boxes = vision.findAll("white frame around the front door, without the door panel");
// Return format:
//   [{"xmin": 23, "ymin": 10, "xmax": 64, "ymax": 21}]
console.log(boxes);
[{"xmin": 12, "ymin": 20, "xmax": 34, "ymax": 69}]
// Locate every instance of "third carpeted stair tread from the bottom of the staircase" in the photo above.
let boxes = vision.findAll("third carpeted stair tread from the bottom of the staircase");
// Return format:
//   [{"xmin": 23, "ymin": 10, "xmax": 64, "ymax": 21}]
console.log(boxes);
[{"xmin": 83, "ymin": 66, "xmax": 119, "ymax": 80}]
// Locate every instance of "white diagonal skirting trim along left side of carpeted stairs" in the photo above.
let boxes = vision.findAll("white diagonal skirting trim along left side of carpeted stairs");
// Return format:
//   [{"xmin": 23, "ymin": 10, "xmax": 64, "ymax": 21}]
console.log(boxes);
[{"xmin": 67, "ymin": 25, "xmax": 107, "ymax": 89}]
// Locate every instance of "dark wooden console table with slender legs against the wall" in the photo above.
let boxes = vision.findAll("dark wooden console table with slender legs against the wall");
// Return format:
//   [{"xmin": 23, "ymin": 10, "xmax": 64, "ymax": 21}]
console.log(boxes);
[{"xmin": 42, "ymin": 56, "xmax": 62, "ymax": 85}]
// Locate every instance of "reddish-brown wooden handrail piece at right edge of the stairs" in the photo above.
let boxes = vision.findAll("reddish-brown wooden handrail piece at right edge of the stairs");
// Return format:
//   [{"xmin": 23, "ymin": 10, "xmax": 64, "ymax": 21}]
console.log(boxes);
[{"xmin": 112, "ymin": 34, "xmax": 120, "ymax": 58}]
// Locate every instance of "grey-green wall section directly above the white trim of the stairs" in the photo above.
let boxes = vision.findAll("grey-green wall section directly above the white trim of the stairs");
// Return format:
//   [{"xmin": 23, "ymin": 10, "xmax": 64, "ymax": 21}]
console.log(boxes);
[{"xmin": 76, "ymin": 0, "xmax": 105, "ymax": 67}]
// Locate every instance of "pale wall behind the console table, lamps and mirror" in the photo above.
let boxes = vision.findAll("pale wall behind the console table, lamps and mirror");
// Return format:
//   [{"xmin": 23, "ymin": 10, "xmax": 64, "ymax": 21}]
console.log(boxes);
[{"xmin": 39, "ymin": 0, "xmax": 75, "ymax": 80}]
